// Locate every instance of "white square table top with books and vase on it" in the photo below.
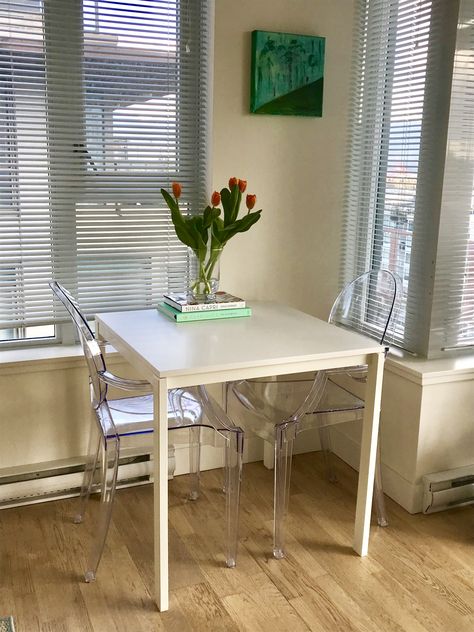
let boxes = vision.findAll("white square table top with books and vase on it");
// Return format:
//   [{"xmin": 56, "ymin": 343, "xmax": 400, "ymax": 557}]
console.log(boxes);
[{"xmin": 97, "ymin": 301, "xmax": 383, "ymax": 377}]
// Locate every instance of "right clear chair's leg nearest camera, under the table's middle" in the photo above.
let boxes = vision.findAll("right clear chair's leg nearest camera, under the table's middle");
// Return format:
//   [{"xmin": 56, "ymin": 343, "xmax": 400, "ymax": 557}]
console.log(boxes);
[{"xmin": 273, "ymin": 422, "xmax": 297, "ymax": 560}]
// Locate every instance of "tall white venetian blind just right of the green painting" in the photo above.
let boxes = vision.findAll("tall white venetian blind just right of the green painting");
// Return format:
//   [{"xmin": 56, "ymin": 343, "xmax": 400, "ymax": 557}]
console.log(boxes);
[{"xmin": 343, "ymin": 0, "xmax": 457, "ymax": 352}]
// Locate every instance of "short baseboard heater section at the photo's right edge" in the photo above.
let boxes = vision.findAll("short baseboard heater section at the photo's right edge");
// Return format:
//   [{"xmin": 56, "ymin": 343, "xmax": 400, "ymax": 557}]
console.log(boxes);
[{"xmin": 423, "ymin": 465, "xmax": 474, "ymax": 514}]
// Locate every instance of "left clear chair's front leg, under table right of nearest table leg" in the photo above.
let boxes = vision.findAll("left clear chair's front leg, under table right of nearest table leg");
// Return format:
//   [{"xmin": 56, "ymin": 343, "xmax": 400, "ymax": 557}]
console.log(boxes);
[{"xmin": 225, "ymin": 430, "xmax": 244, "ymax": 568}]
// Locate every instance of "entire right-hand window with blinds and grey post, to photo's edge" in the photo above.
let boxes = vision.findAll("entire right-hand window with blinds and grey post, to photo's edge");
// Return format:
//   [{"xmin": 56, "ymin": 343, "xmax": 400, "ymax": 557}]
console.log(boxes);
[{"xmin": 343, "ymin": 0, "xmax": 474, "ymax": 356}]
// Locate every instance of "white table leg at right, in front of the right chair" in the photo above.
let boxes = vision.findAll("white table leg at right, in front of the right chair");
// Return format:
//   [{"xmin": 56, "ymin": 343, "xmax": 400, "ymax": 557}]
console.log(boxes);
[{"xmin": 353, "ymin": 353, "xmax": 385, "ymax": 556}]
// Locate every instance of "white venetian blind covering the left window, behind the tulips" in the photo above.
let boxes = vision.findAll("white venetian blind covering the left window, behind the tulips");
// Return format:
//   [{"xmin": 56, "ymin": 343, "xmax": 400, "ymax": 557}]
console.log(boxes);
[{"xmin": 0, "ymin": 0, "xmax": 210, "ymax": 328}]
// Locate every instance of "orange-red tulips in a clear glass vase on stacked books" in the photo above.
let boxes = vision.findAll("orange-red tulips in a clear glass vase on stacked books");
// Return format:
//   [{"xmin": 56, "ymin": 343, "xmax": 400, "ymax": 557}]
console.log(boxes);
[{"xmin": 161, "ymin": 178, "xmax": 262, "ymax": 302}]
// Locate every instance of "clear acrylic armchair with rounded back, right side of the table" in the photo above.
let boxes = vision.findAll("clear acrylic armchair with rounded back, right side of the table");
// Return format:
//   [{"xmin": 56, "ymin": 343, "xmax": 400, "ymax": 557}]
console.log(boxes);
[{"xmin": 228, "ymin": 270, "xmax": 400, "ymax": 559}]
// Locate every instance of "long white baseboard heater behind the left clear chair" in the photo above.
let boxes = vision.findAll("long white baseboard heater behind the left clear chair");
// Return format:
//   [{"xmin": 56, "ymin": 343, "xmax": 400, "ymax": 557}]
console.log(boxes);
[{"xmin": 0, "ymin": 446, "xmax": 175, "ymax": 509}]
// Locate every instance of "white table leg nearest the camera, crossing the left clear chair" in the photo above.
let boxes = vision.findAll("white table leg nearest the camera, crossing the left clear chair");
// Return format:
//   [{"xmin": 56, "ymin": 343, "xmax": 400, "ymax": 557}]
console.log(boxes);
[{"xmin": 153, "ymin": 379, "xmax": 169, "ymax": 612}]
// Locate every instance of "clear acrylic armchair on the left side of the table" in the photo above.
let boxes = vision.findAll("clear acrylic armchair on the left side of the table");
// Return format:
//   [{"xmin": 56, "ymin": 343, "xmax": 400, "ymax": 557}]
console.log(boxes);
[{"xmin": 50, "ymin": 281, "xmax": 243, "ymax": 582}]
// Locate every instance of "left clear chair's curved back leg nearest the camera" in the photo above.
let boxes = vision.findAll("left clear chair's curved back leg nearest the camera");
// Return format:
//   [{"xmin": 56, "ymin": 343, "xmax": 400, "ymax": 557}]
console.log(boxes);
[{"xmin": 85, "ymin": 437, "xmax": 120, "ymax": 582}]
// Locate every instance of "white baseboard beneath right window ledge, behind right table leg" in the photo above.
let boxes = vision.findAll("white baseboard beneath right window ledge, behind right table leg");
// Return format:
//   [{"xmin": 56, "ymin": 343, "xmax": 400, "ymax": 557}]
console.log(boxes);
[{"xmin": 331, "ymin": 426, "xmax": 423, "ymax": 514}]
